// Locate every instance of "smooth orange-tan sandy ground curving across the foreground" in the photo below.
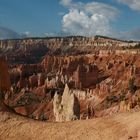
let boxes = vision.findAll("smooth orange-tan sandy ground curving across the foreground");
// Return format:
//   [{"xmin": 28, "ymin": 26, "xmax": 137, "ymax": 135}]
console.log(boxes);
[{"xmin": 0, "ymin": 112, "xmax": 140, "ymax": 140}]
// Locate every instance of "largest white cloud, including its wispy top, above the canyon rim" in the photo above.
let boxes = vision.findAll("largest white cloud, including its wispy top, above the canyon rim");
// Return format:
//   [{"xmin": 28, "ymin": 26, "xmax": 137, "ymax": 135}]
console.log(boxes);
[{"xmin": 61, "ymin": 0, "xmax": 119, "ymax": 36}]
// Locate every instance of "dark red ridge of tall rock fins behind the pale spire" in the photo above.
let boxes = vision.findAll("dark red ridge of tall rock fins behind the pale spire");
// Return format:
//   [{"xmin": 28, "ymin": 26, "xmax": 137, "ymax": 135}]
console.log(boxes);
[{"xmin": 42, "ymin": 55, "xmax": 99, "ymax": 88}]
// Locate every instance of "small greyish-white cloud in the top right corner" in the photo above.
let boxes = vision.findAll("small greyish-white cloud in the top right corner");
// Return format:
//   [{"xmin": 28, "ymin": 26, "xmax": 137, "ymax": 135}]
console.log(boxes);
[{"xmin": 118, "ymin": 0, "xmax": 140, "ymax": 11}]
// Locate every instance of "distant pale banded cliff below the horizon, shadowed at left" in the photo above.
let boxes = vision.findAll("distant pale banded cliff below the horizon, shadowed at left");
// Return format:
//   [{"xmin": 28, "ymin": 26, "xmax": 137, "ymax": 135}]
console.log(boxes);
[{"xmin": 0, "ymin": 36, "xmax": 138, "ymax": 64}]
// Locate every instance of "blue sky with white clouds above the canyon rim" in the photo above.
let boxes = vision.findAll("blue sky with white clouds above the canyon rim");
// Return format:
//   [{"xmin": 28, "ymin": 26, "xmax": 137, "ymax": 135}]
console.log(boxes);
[{"xmin": 0, "ymin": 0, "xmax": 140, "ymax": 40}]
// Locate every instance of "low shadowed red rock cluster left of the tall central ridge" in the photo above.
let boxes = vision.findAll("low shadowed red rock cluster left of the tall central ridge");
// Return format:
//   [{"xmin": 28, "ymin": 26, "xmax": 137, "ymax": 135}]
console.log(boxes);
[{"xmin": 10, "ymin": 64, "xmax": 45, "ymax": 89}]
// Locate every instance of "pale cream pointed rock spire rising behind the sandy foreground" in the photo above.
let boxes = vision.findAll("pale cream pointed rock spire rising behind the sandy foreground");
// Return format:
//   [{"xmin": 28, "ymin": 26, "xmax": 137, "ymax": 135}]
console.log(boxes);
[{"xmin": 53, "ymin": 84, "xmax": 80, "ymax": 122}]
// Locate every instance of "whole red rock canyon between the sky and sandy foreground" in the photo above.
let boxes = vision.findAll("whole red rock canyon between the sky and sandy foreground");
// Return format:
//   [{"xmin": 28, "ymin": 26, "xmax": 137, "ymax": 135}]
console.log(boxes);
[{"xmin": 0, "ymin": 36, "xmax": 140, "ymax": 139}]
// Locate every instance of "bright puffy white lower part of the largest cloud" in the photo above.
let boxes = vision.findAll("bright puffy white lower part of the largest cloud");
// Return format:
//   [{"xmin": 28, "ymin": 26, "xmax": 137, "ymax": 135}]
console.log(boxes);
[{"xmin": 63, "ymin": 9, "xmax": 111, "ymax": 36}]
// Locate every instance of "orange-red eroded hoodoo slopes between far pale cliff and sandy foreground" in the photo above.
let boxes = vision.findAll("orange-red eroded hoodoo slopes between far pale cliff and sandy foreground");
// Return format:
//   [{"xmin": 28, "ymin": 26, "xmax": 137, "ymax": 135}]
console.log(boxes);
[{"xmin": 1, "ymin": 53, "xmax": 140, "ymax": 121}]
